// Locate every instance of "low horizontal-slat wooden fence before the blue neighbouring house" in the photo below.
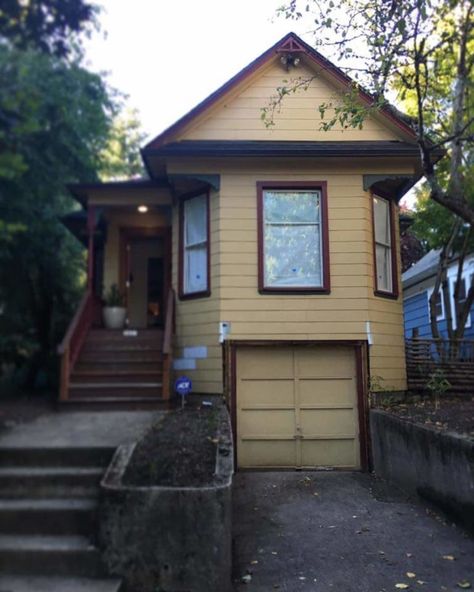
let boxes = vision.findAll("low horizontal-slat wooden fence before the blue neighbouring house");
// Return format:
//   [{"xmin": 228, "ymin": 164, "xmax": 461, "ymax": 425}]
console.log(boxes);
[{"xmin": 406, "ymin": 337, "xmax": 474, "ymax": 395}]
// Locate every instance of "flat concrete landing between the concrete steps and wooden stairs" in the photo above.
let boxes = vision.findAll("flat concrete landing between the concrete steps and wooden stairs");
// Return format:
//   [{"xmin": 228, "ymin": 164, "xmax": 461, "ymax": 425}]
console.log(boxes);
[{"xmin": 0, "ymin": 411, "xmax": 159, "ymax": 448}]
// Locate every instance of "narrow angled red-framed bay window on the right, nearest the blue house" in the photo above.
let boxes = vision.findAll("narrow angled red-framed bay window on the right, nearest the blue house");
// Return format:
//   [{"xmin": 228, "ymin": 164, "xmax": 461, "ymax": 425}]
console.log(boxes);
[{"xmin": 373, "ymin": 195, "xmax": 398, "ymax": 297}]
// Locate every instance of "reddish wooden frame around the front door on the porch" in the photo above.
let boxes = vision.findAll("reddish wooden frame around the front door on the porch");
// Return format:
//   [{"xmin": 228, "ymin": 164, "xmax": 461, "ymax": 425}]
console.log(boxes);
[{"xmin": 119, "ymin": 226, "xmax": 171, "ymax": 318}]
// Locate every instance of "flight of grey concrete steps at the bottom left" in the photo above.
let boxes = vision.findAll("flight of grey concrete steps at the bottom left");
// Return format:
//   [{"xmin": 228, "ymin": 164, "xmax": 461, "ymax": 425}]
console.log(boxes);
[{"xmin": 0, "ymin": 447, "xmax": 120, "ymax": 592}]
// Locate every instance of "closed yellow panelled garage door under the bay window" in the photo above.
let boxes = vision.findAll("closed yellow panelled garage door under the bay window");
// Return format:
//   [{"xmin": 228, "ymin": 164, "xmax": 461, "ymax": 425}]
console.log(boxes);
[{"xmin": 236, "ymin": 345, "xmax": 360, "ymax": 468}]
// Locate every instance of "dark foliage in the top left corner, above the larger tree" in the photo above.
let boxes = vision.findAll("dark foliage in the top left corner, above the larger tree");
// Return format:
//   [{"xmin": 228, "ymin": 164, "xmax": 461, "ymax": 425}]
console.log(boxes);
[{"xmin": 0, "ymin": 0, "xmax": 98, "ymax": 57}]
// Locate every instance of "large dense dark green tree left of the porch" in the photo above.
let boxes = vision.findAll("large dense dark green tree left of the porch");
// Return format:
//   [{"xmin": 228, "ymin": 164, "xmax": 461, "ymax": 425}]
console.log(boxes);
[{"xmin": 0, "ymin": 47, "xmax": 116, "ymax": 382}]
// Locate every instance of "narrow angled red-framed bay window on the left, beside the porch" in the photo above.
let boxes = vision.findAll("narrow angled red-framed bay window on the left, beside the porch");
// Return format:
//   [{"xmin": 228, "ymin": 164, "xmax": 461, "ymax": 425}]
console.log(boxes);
[{"xmin": 180, "ymin": 194, "xmax": 210, "ymax": 298}]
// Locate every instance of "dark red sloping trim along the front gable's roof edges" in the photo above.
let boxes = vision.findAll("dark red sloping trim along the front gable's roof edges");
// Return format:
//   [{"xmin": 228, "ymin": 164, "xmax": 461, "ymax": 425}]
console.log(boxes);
[{"xmin": 142, "ymin": 33, "xmax": 415, "ymax": 157}]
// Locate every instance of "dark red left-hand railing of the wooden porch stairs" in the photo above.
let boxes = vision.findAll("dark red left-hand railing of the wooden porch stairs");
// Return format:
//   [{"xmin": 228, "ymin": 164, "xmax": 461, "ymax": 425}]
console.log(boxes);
[{"xmin": 58, "ymin": 290, "xmax": 99, "ymax": 401}]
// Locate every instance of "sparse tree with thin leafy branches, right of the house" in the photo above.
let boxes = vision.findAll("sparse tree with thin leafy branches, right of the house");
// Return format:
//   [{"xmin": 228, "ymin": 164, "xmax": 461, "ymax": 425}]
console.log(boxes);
[{"xmin": 276, "ymin": 0, "xmax": 474, "ymax": 337}]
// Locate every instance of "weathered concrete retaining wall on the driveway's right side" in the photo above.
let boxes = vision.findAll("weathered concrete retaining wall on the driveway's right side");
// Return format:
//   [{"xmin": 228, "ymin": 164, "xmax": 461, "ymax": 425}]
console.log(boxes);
[{"xmin": 370, "ymin": 410, "xmax": 474, "ymax": 529}]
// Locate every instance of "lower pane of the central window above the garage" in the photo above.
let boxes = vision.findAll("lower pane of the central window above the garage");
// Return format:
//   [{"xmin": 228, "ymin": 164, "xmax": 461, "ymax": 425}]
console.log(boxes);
[{"xmin": 265, "ymin": 224, "xmax": 322, "ymax": 287}]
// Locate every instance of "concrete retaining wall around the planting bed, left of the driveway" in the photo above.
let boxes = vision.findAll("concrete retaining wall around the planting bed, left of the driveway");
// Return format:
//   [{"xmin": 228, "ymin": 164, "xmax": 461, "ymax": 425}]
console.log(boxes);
[{"xmin": 100, "ymin": 408, "xmax": 233, "ymax": 592}]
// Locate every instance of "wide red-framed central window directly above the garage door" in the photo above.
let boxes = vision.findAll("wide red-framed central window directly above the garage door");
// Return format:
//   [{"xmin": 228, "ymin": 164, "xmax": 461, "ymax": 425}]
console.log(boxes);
[{"xmin": 258, "ymin": 183, "xmax": 329, "ymax": 292}]
